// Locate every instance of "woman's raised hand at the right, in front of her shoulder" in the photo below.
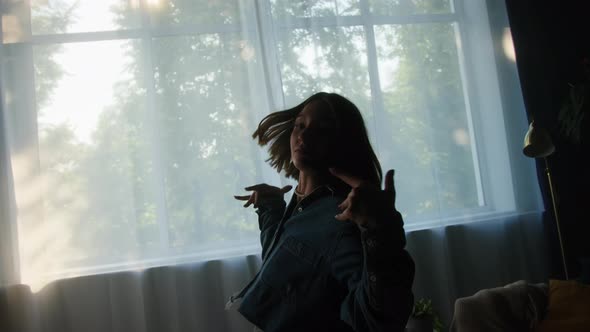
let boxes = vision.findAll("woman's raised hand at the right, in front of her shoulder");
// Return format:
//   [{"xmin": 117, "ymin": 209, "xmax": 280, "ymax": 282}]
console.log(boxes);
[{"xmin": 330, "ymin": 168, "xmax": 396, "ymax": 226}]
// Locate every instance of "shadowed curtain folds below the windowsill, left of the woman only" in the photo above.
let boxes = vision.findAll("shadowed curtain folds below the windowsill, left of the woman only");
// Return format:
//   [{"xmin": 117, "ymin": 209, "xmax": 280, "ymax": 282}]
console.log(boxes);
[{"xmin": 0, "ymin": 256, "xmax": 260, "ymax": 332}]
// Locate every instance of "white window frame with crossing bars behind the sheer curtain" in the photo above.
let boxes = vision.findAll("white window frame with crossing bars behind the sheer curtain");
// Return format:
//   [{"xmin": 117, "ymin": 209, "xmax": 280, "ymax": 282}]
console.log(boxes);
[{"xmin": 0, "ymin": 0, "xmax": 528, "ymax": 277}]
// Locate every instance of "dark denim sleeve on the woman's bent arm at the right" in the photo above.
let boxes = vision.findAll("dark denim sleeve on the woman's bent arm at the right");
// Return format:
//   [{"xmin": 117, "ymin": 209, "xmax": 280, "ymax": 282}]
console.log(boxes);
[{"xmin": 331, "ymin": 211, "xmax": 414, "ymax": 332}]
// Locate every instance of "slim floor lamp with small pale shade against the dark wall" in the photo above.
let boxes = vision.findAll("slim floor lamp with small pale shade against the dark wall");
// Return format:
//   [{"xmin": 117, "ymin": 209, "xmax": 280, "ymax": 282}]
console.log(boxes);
[{"xmin": 522, "ymin": 121, "xmax": 569, "ymax": 280}]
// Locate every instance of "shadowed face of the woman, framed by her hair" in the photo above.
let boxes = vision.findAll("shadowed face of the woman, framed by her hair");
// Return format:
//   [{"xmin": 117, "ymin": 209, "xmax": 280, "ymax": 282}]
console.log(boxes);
[{"xmin": 290, "ymin": 101, "xmax": 338, "ymax": 172}]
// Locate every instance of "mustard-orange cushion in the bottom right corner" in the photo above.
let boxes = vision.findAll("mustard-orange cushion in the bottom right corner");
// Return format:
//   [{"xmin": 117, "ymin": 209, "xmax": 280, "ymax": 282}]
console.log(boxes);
[{"xmin": 536, "ymin": 279, "xmax": 590, "ymax": 332}]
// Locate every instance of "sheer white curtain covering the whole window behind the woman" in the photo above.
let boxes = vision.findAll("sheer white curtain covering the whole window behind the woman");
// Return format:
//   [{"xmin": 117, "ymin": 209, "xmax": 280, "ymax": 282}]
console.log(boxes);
[{"xmin": 0, "ymin": 0, "xmax": 542, "ymax": 331}]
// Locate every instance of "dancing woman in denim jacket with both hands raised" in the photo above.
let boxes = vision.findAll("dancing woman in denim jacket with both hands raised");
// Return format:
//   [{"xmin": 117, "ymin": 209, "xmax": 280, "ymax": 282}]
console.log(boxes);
[{"xmin": 228, "ymin": 92, "xmax": 414, "ymax": 332}]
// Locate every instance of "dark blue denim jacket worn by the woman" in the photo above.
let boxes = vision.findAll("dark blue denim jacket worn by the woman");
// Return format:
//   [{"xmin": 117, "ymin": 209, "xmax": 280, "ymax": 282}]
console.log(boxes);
[{"xmin": 228, "ymin": 187, "xmax": 414, "ymax": 332}]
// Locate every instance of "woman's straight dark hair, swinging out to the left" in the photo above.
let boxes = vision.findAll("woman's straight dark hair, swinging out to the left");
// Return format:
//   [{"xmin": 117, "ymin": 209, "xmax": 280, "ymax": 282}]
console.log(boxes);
[{"xmin": 252, "ymin": 92, "xmax": 383, "ymax": 185}]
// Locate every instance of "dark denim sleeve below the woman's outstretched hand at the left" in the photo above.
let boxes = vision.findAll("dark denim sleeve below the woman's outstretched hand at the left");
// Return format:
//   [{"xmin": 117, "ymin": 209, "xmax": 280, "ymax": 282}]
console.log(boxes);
[{"xmin": 256, "ymin": 197, "xmax": 286, "ymax": 260}]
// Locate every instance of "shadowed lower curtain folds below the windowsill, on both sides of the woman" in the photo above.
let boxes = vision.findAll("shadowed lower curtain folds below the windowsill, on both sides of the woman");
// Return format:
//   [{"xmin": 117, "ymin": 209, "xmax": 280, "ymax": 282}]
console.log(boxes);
[{"xmin": 0, "ymin": 213, "xmax": 547, "ymax": 332}]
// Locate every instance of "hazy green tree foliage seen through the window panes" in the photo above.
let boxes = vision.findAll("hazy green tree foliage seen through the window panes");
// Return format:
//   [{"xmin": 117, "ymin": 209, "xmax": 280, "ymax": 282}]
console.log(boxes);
[{"xmin": 24, "ymin": 0, "xmax": 477, "ymax": 265}]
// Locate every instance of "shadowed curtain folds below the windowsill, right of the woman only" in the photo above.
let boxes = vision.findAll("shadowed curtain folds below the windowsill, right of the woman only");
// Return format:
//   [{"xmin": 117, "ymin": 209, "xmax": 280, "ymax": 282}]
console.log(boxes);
[{"xmin": 408, "ymin": 212, "xmax": 548, "ymax": 323}]
